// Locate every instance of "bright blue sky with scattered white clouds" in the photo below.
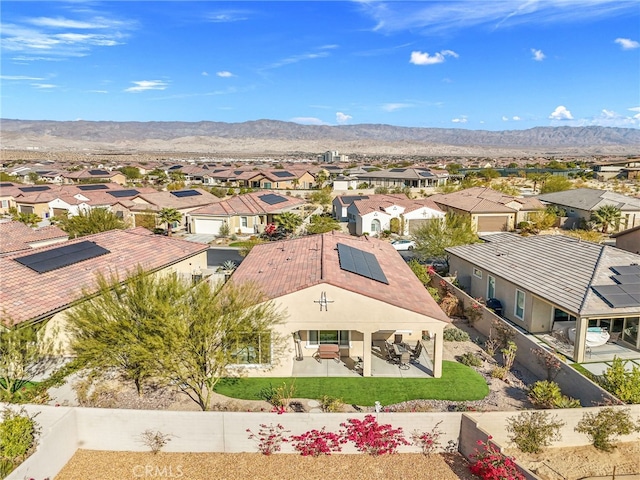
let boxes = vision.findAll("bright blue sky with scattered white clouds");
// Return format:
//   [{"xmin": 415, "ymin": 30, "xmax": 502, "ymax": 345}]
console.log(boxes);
[{"xmin": 0, "ymin": 0, "xmax": 640, "ymax": 130}]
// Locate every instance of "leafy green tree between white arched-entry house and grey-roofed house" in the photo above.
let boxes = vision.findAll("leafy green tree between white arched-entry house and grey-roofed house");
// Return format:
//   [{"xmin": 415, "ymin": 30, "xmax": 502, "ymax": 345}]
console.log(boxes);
[{"xmin": 413, "ymin": 213, "xmax": 479, "ymax": 260}]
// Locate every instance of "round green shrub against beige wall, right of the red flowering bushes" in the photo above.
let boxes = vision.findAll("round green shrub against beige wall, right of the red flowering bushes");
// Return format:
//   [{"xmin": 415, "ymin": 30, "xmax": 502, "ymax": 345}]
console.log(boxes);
[{"xmin": 507, "ymin": 411, "xmax": 564, "ymax": 453}]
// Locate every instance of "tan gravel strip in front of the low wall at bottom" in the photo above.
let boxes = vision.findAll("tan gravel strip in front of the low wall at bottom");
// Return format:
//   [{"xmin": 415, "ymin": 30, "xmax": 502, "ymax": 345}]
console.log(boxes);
[{"xmin": 55, "ymin": 450, "xmax": 477, "ymax": 480}]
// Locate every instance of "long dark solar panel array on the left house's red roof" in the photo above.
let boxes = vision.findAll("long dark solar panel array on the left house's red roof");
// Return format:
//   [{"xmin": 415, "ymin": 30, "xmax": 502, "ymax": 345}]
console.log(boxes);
[{"xmin": 15, "ymin": 240, "xmax": 110, "ymax": 273}]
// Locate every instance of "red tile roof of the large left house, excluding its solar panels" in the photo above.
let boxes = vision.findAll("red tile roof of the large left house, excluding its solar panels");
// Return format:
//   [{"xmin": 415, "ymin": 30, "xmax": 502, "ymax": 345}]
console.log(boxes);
[{"xmin": 0, "ymin": 228, "xmax": 209, "ymax": 323}]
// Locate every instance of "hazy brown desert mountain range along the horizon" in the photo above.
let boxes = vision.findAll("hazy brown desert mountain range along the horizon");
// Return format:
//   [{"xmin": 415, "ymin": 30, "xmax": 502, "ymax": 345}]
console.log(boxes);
[{"xmin": 0, "ymin": 119, "xmax": 640, "ymax": 155}]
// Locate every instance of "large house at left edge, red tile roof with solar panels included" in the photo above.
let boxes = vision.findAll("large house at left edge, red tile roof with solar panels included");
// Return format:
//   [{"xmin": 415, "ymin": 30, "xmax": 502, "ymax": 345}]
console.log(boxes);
[{"xmin": 0, "ymin": 228, "xmax": 209, "ymax": 353}]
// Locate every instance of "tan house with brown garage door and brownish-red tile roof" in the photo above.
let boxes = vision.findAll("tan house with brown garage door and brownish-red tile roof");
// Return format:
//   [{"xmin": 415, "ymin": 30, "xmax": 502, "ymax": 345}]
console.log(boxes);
[{"xmin": 429, "ymin": 187, "xmax": 544, "ymax": 233}]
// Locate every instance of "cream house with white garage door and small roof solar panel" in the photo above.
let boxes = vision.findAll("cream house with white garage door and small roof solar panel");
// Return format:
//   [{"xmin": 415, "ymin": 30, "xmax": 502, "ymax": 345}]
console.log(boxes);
[{"xmin": 187, "ymin": 191, "xmax": 306, "ymax": 235}]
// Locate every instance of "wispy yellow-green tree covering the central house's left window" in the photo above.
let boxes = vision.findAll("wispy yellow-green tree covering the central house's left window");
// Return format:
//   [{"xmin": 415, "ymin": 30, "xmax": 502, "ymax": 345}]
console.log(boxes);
[{"xmin": 155, "ymin": 278, "xmax": 285, "ymax": 410}]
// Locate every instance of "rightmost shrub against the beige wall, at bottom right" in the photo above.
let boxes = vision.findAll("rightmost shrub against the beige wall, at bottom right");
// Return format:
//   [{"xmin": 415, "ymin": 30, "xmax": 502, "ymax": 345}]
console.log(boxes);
[{"xmin": 575, "ymin": 407, "xmax": 640, "ymax": 452}]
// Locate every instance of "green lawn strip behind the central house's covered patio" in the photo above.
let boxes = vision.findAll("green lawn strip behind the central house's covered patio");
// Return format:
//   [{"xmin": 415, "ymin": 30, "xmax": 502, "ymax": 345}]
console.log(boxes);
[{"xmin": 215, "ymin": 361, "xmax": 489, "ymax": 406}]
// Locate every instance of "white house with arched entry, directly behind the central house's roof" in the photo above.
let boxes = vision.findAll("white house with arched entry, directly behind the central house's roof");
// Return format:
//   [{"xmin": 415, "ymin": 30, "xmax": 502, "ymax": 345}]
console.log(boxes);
[{"xmin": 347, "ymin": 195, "xmax": 445, "ymax": 235}]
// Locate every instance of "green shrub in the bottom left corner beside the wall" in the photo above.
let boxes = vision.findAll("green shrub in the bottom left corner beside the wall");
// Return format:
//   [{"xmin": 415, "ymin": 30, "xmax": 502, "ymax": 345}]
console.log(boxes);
[{"xmin": 0, "ymin": 407, "xmax": 40, "ymax": 478}]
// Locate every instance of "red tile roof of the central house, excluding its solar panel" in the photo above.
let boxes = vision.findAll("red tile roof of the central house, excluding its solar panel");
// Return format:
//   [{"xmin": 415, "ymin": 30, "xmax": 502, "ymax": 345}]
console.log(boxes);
[{"xmin": 231, "ymin": 232, "xmax": 450, "ymax": 322}]
